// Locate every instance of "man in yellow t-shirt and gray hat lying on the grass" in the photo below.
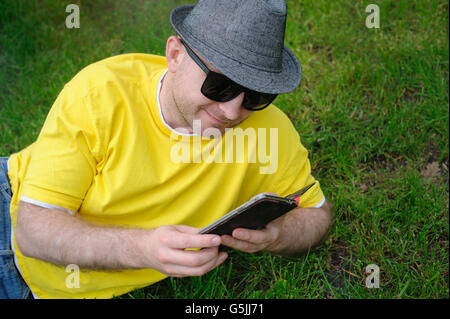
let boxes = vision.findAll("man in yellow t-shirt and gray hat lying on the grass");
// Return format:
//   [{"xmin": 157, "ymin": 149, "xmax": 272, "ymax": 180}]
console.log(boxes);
[{"xmin": 2, "ymin": 0, "xmax": 330, "ymax": 298}]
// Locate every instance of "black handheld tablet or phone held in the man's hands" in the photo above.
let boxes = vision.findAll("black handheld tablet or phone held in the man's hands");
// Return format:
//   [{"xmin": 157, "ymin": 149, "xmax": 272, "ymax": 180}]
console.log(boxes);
[{"xmin": 199, "ymin": 194, "xmax": 297, "ymax": 235}]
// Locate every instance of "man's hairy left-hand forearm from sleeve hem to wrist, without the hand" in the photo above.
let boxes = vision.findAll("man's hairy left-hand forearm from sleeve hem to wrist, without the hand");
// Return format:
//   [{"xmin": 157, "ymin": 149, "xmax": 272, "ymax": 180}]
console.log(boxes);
[{"xmin": 16, "ymin": 202, "xmax": 149, "ymax": 269}]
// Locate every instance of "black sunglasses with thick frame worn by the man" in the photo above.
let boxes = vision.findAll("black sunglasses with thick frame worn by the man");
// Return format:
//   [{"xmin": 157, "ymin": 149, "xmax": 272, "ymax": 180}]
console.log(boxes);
[{"xmin": 180, "ymin": 39, "xmax": 278, "ymax": 111}]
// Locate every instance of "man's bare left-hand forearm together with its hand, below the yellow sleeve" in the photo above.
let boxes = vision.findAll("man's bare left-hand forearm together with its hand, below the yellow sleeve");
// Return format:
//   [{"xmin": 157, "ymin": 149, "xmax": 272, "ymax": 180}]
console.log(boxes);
[{"xmin": 16, "ymin": 203, "xmax": 227, "ymax": 277}]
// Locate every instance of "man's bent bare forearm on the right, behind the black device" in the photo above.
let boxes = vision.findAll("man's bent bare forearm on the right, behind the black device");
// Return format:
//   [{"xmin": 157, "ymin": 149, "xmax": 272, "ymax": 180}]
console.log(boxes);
[{"xmin": 267, "ymin": 202, "xmax": 332, "ymax": 256}]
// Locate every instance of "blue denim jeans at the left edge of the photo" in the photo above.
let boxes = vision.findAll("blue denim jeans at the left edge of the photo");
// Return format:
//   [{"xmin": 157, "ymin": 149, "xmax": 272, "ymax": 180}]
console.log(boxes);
[{"xmin": 0, "ymin": 157, "xmax": 32, "ymax": 299}]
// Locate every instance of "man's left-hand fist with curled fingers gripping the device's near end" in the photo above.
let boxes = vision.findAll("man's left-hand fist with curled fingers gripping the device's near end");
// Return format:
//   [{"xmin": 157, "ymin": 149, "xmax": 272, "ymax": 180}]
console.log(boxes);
[{"xmin": 146, "ymin": 225, "xmax": 227, "ymax": 277}]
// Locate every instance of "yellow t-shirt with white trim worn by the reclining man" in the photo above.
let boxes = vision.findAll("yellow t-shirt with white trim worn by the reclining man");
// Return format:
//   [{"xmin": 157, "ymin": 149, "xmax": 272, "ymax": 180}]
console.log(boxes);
[{"xmin": 8, "ymin": 54, "xmax": 324, "ymax": 298}]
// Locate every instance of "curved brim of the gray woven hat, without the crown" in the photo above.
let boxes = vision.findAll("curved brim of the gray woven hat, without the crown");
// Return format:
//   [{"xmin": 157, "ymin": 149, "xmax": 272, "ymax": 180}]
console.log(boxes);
[{"xmin": 170, "ymin": 5, "xmax": 301, "ymax": 94}]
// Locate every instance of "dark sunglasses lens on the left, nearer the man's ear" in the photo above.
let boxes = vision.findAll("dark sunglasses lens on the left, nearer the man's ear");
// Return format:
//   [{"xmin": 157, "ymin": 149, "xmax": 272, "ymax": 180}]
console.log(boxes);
[{"xmin": 201, "ymin": 72, "xmax": 242, "ymax": 102}]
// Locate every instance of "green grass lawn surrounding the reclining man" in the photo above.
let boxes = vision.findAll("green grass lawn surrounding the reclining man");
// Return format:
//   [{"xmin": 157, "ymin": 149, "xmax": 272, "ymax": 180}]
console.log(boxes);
[{"xmin": 0, "ymin": 0, "xmax": 449, "ymax": 298}]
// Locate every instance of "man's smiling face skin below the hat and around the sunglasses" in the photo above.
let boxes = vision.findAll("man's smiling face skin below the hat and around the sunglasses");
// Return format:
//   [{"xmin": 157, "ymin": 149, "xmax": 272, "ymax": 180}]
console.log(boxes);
[{"xmin": 168, "ymin": 40, "xmax": 253, "ymax": 134}]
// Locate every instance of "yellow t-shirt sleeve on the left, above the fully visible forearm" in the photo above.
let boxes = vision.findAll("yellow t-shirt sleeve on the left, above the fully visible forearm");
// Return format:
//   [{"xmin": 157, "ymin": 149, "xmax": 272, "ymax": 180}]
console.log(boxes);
[{"xmin": 21, "ymin": 85, "xmax": 103, "ymax": 212}]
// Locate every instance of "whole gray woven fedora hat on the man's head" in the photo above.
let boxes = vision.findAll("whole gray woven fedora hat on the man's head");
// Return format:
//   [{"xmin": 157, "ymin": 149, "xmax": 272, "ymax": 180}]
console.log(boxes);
[{"xmin": 170, "ymin": 0, "xmax": 301, "ymax": 94}]
